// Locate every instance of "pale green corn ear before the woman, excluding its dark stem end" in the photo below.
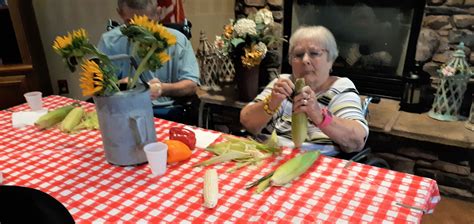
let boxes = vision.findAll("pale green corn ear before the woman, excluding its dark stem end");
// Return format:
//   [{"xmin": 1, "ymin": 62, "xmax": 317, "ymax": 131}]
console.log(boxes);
[{"xmin": 271, "ymin": 151, "xmax": 320, "ymax": 186}]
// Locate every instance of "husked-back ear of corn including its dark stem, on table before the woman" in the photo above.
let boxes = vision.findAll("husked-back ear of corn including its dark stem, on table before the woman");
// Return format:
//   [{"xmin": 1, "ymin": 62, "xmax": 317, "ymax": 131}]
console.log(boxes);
[{"xmin": 247, "ymin": 151, "xmax": 320, "ymax": 194}]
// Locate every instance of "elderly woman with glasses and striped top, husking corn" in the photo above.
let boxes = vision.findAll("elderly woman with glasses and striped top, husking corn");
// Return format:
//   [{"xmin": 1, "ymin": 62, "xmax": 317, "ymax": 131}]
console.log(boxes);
[{"xmin": 240, "ymin": 26, "xmax": 369, "ymax": 152}]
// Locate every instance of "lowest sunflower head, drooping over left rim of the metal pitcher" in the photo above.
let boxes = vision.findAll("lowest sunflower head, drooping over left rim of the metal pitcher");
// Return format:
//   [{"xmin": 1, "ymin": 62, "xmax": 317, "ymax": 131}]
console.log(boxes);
[{"xmin": 79, "ymin": 60, "xmax": 104, "ymax": 96}]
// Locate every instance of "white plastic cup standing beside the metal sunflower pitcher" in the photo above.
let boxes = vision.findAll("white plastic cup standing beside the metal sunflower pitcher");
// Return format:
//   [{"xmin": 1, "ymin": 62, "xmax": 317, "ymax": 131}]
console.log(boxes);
[{"xmin": 143, "ymin": 142, "xmax": 168, "ymax": 177}]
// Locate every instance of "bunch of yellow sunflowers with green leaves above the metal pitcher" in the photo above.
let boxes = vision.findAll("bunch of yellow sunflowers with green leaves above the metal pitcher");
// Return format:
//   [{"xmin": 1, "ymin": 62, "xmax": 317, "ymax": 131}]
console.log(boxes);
[{"xmin": 53, "ymin": 15, "xmax": 176, "ymax": 96}]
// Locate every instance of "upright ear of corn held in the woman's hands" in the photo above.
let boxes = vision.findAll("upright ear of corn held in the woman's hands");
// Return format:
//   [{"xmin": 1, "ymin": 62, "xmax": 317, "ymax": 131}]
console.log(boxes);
[{"xmin": 291, "ymin": 78, "xmax": 308, "ymax": 148}]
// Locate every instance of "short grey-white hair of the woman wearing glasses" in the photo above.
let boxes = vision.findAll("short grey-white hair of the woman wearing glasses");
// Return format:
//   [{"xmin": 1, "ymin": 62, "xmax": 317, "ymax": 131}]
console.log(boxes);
[{"xmin": 288, "ymin": 26, "xmax": 339, "ymax": 62}]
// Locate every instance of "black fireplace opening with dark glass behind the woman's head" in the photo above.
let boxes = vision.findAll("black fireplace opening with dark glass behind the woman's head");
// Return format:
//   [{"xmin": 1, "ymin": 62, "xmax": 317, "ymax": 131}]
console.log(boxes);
[{"xmin": 282, "ymin": 0, "xmax": 426, "ymax": 100}]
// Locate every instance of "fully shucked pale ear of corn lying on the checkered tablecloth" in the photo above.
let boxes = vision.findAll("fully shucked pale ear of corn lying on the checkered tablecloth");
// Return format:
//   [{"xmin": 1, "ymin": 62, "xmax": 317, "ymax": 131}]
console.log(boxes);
[{"xmin": 203, "ymin": 169, "xmax": 219, "ymax": 208}]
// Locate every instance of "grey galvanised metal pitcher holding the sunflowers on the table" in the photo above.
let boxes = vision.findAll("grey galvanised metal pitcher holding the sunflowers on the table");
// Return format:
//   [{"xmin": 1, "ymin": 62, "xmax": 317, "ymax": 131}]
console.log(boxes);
[{"xmin": 93, "ymin": 86, "xmax": 156, "ymax": 166}]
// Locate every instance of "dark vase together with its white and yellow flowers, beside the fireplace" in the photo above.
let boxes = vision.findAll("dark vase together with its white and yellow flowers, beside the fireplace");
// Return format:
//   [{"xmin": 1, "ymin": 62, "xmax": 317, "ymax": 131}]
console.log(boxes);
[{"xmin": 214, "ymin": 8, "xmax": 284, "ymax": 101}]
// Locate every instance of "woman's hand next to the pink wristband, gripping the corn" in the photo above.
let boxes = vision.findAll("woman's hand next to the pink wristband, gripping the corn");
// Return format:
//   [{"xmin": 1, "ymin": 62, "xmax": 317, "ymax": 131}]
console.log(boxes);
[{"xmin": 293, "ymin": 86, "xmax": 323, "ymax": 125}]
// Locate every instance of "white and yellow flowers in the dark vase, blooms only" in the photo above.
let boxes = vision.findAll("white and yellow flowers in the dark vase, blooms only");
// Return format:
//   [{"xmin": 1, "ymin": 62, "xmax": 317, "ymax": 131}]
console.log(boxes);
[{"xmin": 214, "ymin": 8, "xmax": 283, "ymax": 68}]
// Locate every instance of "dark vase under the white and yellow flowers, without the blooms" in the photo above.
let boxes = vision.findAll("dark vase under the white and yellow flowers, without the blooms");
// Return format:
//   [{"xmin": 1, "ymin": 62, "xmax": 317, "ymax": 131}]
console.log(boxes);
[{"xmin": 234, "ymin": 60, "xmax": 260, "ymax": 102}]
